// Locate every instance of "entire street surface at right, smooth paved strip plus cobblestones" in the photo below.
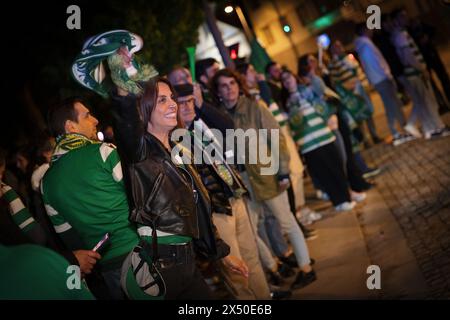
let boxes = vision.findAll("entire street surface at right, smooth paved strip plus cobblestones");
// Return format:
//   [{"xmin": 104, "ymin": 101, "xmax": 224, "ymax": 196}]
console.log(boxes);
[{"xmin": 293, "ymin": 47, "xmax": 450, "ymax": 299}]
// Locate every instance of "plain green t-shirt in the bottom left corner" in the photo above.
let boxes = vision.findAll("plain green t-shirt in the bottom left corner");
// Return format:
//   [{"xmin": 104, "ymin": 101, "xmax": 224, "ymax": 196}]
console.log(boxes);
[{"xmin": 0, "ymin": 244, "xmax": 95, "ymax": 300}]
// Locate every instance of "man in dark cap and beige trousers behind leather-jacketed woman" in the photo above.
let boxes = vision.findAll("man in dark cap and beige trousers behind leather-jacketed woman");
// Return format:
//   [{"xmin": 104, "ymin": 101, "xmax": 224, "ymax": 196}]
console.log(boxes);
[{"xmin": 174, "ymin": 84, "xmax": 270, "ymax": 300}]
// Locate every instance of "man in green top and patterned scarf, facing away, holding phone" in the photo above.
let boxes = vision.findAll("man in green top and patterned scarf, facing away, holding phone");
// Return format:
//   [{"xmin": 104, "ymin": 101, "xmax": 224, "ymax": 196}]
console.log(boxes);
[{"xmin": 41, "ymin": 99, "xmax": 138, "ymax": 299}]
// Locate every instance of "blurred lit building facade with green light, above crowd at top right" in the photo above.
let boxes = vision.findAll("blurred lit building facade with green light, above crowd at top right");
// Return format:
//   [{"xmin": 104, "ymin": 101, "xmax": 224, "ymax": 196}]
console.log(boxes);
[{"xmin": 244, "ymin": 0, "xmax": 450, "ymax": 71}]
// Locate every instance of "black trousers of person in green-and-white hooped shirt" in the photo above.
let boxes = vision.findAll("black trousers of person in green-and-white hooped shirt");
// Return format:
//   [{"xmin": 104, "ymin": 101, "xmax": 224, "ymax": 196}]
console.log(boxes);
[{"xmin": 304, "ymin": 143, "xmax": 350, "ymax": 206}]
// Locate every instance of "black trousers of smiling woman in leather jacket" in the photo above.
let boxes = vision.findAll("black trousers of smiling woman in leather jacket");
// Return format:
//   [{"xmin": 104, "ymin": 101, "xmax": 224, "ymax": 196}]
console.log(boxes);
[{"xmin": 158, "ymin": 242, "xmax": 214, "ymax": 300}]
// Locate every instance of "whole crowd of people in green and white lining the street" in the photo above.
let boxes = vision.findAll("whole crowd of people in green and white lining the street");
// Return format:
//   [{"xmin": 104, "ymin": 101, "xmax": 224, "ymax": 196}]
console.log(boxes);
[{"xmin": 0, "ymin": 10, "xmax": 450, "ymax": 300}]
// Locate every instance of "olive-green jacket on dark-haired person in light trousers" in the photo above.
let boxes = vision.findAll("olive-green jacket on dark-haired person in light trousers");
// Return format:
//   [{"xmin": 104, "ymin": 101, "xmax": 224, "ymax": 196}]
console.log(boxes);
[{"xmin": 222, "ymin": 96, "xmax": 289, "ymax": 200}]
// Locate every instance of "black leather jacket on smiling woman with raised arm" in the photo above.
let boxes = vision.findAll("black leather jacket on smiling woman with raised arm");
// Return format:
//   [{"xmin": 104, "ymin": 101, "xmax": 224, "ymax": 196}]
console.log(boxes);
[{"xmin": 113, "ymin": 95, "xmax": 229, "ymax": 259}]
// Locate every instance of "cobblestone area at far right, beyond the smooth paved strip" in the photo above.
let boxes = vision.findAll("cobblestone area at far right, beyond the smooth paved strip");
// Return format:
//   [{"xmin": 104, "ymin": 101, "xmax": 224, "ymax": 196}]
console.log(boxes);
[{"xmin": 366, "ymin": 127, "xmax": 450, "ymax": 298}]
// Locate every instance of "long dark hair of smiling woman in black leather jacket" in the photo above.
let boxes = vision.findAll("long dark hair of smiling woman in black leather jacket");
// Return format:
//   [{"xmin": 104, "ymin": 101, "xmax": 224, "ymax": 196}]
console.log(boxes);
[{"xmin": 138, "ymin": 77, "xmax": 184, "ymax": 131}]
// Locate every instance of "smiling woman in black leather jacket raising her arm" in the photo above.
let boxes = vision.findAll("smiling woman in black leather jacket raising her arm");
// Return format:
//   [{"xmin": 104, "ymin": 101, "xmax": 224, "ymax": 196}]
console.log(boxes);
[{"xmin": 113, "ymin": 79, "xmax": 229, "ymax": 299}]
